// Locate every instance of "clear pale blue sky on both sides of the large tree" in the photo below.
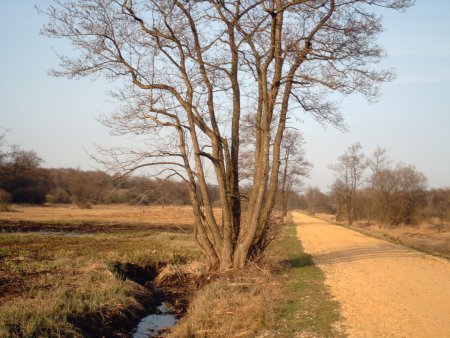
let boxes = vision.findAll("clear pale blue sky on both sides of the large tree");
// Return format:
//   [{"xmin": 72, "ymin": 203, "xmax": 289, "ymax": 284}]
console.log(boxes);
[{"xmin": 0, "ymin": 0, "xmax": 450, "ymax": 191}]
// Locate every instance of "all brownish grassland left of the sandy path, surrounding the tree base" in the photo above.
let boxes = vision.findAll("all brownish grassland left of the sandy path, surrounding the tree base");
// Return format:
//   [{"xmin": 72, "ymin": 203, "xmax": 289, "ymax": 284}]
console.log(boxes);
[{"xmin": 0, "ymin": 206, "xmax": 339, "ymax": 337}]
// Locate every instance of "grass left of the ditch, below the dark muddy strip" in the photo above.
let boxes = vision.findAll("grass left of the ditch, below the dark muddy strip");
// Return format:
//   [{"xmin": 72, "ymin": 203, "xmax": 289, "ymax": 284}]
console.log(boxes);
[{"xmin": 0, "ymin": 230, "xmax": 200, "ymax": 337}]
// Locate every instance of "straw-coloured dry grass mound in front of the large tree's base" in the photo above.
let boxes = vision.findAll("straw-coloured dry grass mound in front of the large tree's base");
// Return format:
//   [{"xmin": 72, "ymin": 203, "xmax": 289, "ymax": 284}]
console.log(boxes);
[{"xmin": 168, "ymin": 267, "xmax": 280, "ymax": 337}]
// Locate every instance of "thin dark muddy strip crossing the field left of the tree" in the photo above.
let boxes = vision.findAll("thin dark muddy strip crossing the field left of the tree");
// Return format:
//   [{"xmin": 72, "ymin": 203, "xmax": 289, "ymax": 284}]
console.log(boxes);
[{"xmin": 0, "ymin": 220, "xmax": 192, "ymax": 234}]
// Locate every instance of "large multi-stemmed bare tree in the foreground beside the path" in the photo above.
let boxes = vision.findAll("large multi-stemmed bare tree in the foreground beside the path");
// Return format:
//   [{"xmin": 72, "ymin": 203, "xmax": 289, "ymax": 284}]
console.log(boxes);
[{"xmin": 44, "ymin": 0, "xmax": 412, "ymax": 269}]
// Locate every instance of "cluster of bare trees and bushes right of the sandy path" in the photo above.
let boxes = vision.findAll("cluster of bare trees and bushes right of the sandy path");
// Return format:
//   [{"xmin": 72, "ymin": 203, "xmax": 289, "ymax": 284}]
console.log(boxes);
[{"xmin": 299, "ymin": 143, "xmax": 450, "ymax": 226}]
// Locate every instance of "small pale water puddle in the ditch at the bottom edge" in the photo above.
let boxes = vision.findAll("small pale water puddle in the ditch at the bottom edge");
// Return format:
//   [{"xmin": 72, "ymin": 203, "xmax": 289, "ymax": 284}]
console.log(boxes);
[{"xmin": 131, "ymin": 303, "xmax": 177, "ymax": 338}]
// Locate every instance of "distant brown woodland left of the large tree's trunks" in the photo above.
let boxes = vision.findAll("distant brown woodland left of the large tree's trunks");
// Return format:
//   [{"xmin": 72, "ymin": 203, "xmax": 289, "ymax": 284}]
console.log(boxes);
[{"xmin": 0, "ymin": 138, "xmax": 198, "ymax": 208}]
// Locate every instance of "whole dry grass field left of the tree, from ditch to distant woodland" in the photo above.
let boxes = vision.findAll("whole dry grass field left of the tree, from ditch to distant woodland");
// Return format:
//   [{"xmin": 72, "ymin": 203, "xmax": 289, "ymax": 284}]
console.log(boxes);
[{"xmin": 0, "ymin": 206, "xmax": 201, "ymax": 337}]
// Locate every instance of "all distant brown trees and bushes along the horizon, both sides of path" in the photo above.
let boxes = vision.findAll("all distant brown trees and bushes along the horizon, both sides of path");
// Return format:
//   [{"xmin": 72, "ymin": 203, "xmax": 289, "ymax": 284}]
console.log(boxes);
[{"xmin": 0, "ymin": 135, "xmax": 442, "ymax": 226}]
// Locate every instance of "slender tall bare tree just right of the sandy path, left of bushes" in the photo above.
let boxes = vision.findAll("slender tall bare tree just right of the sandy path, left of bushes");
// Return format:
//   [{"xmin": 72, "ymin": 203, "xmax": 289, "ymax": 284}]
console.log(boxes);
[{"xmin": 331, "ymin": 143, "xmax": 368, "ymax": 225}]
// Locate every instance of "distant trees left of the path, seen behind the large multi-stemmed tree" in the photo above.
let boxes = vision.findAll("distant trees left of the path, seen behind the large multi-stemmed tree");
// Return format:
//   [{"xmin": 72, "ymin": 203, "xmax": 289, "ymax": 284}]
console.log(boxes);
[{"xmin": 0, "ymin": 132, "xmax": 311, "ymax": 214}]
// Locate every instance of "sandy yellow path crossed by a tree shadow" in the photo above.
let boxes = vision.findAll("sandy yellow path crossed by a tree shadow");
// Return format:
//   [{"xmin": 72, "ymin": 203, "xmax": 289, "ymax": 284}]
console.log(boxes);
[{"xmin": 293, "ymin": 212, "xmax": 450, "ymax": 338}]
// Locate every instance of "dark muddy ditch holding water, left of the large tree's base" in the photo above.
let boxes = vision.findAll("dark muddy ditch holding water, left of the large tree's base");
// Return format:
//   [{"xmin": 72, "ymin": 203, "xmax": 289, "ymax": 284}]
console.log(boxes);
[{"xmin": 76, "ymin": 262, "xmax": 212, "ymax": 337}]
